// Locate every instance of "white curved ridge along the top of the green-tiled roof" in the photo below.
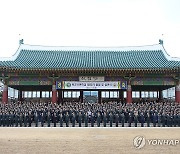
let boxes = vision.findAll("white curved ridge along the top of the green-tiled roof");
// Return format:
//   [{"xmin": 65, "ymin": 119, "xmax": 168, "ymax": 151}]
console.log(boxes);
[{"xmin": 0, "ymin": 44, "xmax": 180, "ymax": 61}]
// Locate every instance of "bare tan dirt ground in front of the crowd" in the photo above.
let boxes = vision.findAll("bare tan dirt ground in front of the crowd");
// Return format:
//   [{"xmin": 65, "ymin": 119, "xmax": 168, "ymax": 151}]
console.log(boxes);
[{"xmin": 0, "ymin": 127, "xmax": 180, "ymax": 154}]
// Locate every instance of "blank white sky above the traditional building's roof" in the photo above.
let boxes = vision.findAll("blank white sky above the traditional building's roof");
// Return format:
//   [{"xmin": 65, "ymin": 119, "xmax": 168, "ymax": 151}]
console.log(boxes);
[{"xmin": 0, "ymin": 0, "xmax": 180, "ymax": 57}]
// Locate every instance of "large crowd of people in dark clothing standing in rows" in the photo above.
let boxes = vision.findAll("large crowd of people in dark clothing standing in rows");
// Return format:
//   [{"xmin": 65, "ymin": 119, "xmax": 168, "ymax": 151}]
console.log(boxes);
[{"xmin": 0, "ymin": 101, "xmax": 180, "ymax": 127}]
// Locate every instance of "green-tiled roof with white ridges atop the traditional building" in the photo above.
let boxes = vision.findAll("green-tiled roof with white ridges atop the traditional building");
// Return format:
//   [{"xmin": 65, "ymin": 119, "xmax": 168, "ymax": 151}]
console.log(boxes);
[{"xmin": 0, "ymin": 44, "xmax": 180, "ymax": 69}]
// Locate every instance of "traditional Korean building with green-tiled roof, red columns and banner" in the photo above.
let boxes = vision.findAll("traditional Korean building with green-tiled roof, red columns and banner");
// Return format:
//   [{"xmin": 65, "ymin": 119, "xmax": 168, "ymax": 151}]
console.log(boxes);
[{"xmin": 0, "ymin": 43, "xmax": 180, "ymax": 103}]
